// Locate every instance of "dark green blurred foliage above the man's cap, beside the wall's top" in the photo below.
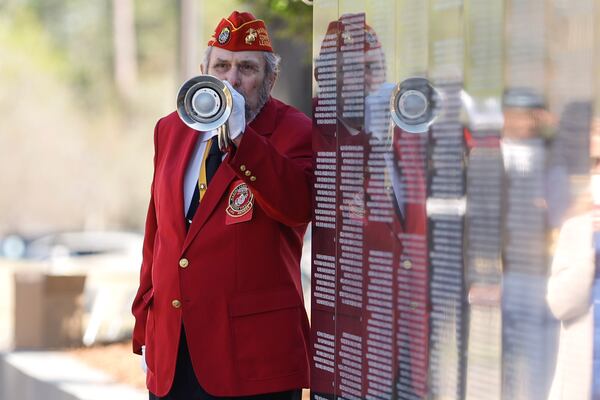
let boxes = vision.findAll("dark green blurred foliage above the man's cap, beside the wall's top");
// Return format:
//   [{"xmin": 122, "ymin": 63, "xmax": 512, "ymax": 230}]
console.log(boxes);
[{"xmin": 239, "ymin": 0, "xmax": 313, "ymax": 43}]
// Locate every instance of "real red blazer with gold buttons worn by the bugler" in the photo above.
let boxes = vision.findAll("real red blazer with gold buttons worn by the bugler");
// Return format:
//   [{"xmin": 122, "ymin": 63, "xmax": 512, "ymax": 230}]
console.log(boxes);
[{"xmin": 132, "ymin": 99, "xmax": 313, "ymax": 396}]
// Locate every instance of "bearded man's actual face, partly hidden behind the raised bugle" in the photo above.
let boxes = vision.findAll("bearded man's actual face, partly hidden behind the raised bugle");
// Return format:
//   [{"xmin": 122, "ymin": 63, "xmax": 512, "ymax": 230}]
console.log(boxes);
[{"xmin": 202, "ymin": 47, "xmax": 272, "ymax": 116}]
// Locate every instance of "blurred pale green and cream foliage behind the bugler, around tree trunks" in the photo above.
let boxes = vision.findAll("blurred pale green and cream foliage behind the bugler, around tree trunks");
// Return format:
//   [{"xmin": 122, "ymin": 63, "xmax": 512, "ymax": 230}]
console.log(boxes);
[{"xmin": 0, "ymin": 0, "xmax": 312, "ymax": 236}]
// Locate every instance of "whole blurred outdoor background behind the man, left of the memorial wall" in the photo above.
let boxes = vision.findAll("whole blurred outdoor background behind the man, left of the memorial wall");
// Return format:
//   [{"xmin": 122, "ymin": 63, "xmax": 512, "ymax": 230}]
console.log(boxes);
[{"xmin": 0, "ymin": 0, "xmax": 312, "ymax": 399}]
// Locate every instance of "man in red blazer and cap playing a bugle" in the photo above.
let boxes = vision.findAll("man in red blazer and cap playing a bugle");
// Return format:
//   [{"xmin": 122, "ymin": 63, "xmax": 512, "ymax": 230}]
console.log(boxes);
[{"xmin": 132, "ymin": 12, "xmax": 313, "ymax": 400}]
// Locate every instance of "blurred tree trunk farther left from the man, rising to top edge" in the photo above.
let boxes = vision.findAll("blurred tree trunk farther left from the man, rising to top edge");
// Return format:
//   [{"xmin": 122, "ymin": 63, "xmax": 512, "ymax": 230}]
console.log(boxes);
[{"xmin": 113, "ymin": 0, "xmax": 137, "ymax": 98}]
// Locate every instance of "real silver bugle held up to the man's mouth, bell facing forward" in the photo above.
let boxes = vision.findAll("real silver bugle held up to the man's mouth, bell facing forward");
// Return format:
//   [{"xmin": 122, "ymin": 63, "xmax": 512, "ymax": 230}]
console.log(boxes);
[{"xmin": 177, "ymin": 75, "xmax": 233, "ymax": 150}]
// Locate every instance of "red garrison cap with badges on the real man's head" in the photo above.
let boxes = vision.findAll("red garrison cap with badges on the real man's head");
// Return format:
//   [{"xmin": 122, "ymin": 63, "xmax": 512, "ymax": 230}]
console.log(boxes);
[{"xmin": 208, "ymin": 11, "xmax": 273, "ymax": 53}]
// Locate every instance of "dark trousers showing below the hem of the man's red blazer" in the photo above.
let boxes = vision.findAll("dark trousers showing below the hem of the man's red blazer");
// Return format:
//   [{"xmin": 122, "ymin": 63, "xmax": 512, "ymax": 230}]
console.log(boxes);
[{"xmin": 149, "ymin": 326, "xmax": 302, "ymax": 400}]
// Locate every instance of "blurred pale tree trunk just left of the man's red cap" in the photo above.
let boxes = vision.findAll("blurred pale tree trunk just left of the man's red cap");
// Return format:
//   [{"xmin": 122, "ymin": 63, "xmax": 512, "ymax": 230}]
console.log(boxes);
[{"xmin": 179, "ymin": 0, "xmax": 201, "ymax": 82}]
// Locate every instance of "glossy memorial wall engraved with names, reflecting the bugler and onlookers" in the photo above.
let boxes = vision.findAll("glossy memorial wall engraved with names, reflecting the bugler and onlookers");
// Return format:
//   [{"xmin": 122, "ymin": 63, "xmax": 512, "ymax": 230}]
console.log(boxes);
[{"xmin": 311, "ymin": 0, "xmax": 600, "ymax": 400}]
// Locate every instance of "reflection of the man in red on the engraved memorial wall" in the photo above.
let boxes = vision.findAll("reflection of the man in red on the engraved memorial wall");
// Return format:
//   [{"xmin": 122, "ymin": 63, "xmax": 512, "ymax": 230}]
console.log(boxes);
[{"xmin": 312, "ymin": 14, "xmax": 430, "ymax": 399}]
